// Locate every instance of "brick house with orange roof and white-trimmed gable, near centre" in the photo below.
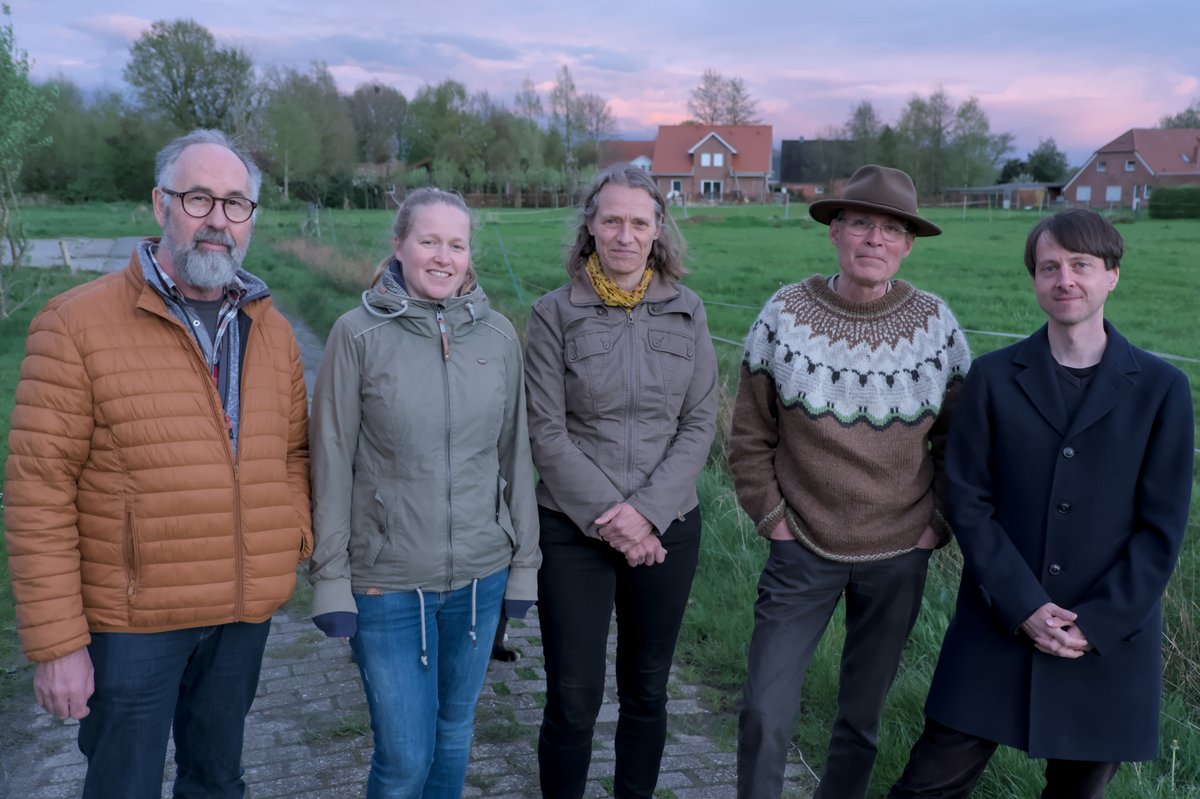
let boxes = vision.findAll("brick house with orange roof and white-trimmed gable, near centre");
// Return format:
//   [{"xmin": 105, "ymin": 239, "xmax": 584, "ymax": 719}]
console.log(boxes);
[{"xmin": 650, "ymin": 125, "xmax": 772, "ymax": 203}]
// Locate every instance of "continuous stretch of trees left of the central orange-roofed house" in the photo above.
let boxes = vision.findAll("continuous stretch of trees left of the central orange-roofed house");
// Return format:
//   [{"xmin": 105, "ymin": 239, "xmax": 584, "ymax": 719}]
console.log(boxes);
[{"xmin": 20, "ymin": 19, "xmax": 617, "ymax": 206}]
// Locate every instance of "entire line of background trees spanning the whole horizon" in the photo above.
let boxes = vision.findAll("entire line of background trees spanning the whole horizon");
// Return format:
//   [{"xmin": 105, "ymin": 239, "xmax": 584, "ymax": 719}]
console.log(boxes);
[{"xmin": 9, "ymin": 16, "xmax": 1200, "ymax": 214}]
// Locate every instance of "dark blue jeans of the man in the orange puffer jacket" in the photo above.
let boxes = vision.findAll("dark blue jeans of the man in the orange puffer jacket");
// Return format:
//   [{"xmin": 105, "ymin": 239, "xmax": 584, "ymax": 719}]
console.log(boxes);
[{"xmin": 79, "ymin": 621, "xmax": 271, "ymax": 799}]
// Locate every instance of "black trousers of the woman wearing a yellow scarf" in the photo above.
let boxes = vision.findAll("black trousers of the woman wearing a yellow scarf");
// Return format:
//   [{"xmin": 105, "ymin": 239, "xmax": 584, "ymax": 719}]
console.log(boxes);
[{"xmin": 538, "ymin": 507, "xmax": 700, "ymax": 799}]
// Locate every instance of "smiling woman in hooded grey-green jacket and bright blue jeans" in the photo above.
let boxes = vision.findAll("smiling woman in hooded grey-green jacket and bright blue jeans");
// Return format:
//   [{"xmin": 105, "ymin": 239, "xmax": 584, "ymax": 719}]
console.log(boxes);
[{"xmin": 310, "ymin": 188, "xmax": 541, "ymax": 799}]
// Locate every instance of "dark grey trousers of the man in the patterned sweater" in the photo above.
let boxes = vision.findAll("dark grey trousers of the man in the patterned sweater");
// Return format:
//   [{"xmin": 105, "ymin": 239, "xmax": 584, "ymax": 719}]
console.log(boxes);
[{"xmin": 738, "ymin": 541, "xmax": 930, "ymax": 799}]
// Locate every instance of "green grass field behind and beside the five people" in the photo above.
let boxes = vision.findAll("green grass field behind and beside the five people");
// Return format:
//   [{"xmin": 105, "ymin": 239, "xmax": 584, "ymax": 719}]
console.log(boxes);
[{"xmin": 0, "ymin": 205, "xmax": 1200, "ymax": 799}]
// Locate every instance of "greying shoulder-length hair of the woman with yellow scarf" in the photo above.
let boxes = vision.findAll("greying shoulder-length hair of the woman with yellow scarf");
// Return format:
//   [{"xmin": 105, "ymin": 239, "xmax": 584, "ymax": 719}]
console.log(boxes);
[{"xmin": 566, "ymin": 163, "xmax": 688, "ymax": 282}]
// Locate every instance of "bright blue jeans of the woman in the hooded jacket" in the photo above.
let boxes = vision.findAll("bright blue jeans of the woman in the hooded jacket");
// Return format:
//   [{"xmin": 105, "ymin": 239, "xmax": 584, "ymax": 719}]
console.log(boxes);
[{"xmin": 350, "ymin": 569, "xmax": 509, "ymax": 799}]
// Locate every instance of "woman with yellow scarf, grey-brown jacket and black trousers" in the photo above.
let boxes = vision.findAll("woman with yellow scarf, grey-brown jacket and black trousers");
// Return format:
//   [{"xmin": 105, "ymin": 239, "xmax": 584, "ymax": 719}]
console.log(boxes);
[{"xmin": 526, "ymin": 164, "xmax": 716, "ymax": 799}]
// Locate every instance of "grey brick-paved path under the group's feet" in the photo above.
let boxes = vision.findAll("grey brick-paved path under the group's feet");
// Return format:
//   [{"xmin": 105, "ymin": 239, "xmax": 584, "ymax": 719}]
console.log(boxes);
[{"xmin": 0, "ymin": 244, "xmax": 814, "ymax": 799}]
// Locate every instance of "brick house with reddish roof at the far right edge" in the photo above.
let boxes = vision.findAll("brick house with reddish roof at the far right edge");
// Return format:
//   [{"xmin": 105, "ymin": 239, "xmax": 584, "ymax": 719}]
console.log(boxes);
[{"xmin": 1063, "ymin": 128, "xmax": 1200, "ymax": 210}]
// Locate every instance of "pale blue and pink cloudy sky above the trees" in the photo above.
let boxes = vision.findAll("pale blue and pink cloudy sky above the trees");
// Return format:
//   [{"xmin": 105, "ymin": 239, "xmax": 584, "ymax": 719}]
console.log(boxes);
[{"xmin": 7, "ymin": 0, "xmax": 1200, "ymax": 164}]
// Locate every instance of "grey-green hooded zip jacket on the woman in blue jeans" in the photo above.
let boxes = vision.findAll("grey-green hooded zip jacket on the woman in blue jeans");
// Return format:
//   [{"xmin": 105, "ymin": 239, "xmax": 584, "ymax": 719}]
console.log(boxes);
[{"xmin": 308, "ymin": 267, "xmax": 541, "ymax": 615}]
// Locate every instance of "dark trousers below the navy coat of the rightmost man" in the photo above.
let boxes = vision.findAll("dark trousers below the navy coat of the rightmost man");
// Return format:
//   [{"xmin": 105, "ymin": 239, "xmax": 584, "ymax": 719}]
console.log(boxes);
[{"xmin": 888, "ymin": 719, "xmax": 1121, "ymax": 799}]
